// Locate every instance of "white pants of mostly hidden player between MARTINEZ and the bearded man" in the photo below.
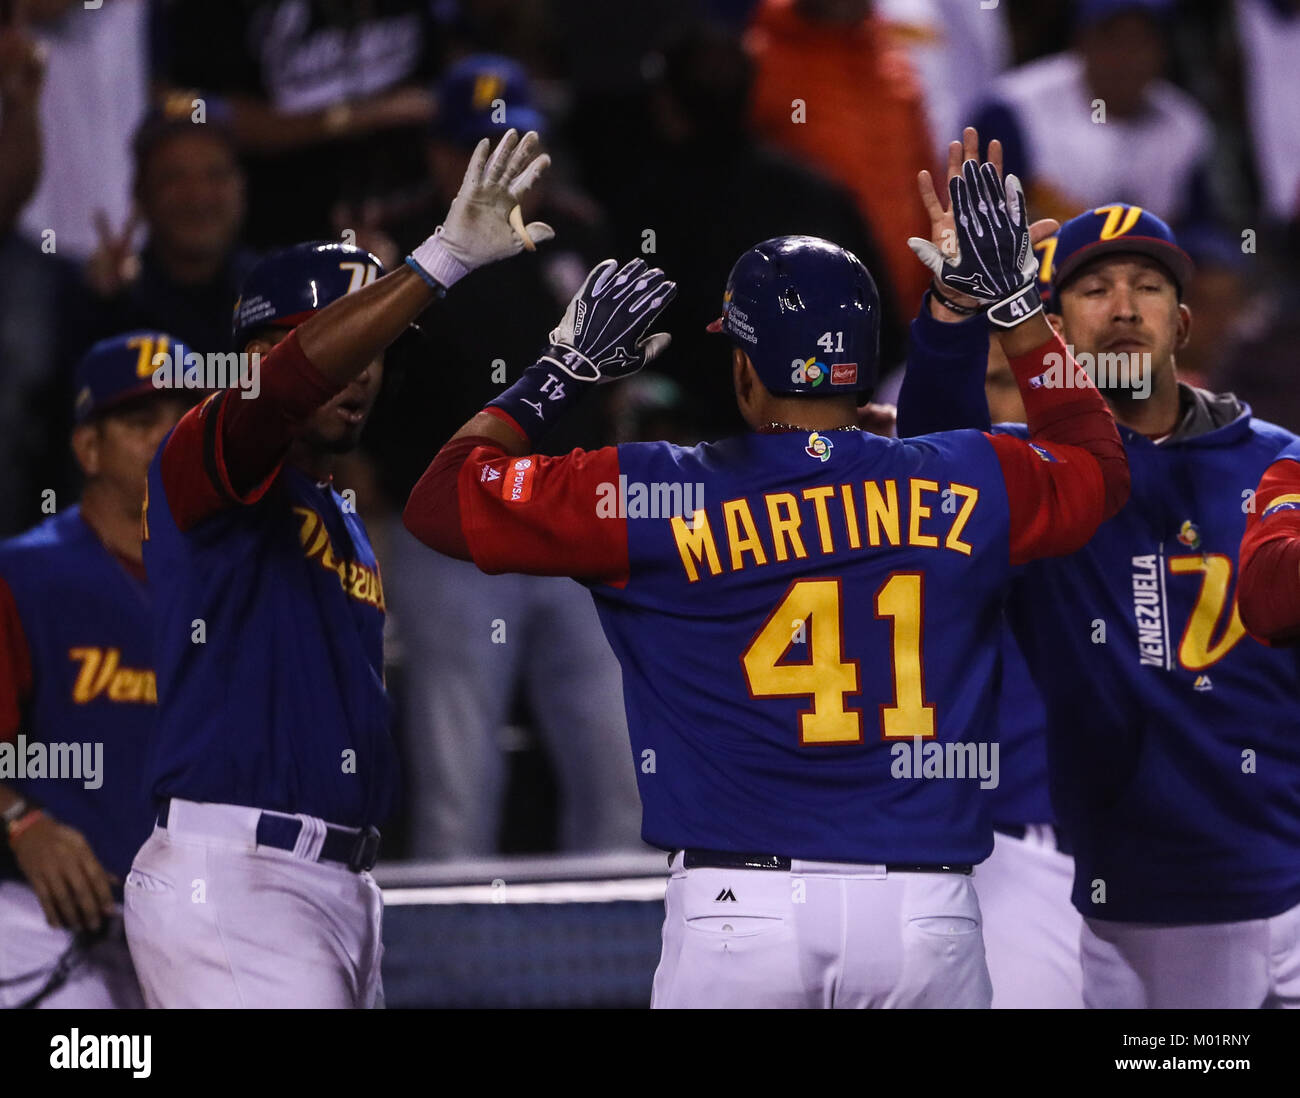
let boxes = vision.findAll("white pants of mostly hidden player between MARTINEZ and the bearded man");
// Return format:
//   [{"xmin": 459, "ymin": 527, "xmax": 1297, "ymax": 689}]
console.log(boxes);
[{"xmin": 975, "ymin": 824, "xmax": 1083, "ymax": 1010}]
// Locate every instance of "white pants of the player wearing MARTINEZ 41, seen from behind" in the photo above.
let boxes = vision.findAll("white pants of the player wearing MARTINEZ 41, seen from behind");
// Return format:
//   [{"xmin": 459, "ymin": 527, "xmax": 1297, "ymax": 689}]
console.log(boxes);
[{"xmin": 650, "ymin": 851, "xmax": 992, "ymax": 1008}]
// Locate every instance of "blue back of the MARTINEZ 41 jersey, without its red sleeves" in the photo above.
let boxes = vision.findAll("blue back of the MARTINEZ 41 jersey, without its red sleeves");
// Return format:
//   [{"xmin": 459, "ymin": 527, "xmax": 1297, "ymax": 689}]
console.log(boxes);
[{"xmin": 593, "ymin": 431, "xmax": 1009, "ymax": 863}]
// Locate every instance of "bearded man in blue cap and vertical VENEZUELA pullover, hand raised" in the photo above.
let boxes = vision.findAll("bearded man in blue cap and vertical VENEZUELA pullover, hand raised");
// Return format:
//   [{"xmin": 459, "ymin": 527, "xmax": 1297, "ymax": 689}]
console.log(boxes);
[{"xmin": 900, "ymin": 163, "xmax": 1300, "ymax": 1007}]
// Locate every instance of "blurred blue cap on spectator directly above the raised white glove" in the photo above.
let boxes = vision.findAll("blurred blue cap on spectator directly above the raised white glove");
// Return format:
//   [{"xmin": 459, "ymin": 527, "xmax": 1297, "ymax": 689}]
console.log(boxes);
[{"xmin": 432, "ymin": 53, "xmax": 546, "ymax": 148}]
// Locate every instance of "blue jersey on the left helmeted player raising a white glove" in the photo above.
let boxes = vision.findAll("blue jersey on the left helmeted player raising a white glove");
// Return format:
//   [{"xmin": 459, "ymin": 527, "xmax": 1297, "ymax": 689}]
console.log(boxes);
[{"xmin": 144, "ymin": 399, "xmax": 398, "ymax": 826}]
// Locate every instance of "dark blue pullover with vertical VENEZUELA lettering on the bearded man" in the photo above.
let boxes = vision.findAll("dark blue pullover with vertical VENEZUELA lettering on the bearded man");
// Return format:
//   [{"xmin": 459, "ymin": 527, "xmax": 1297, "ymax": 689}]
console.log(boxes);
[{"xmin": 900, "ymin": 307, "xmax": 1300, "ymax": 923}]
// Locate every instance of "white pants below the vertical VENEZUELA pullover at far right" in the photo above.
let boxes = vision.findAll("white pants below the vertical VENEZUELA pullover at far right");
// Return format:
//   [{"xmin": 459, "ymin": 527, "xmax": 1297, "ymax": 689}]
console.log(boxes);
[{"xmin": 1083, "ymin": 904, "xmax": 1300, "ymax": 1010}]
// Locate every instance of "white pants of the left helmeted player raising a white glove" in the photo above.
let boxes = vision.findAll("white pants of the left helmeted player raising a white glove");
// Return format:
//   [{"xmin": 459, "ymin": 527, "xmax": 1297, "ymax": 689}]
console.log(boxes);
[{"xmin": 125, "ymin": 799, "xmax": 384, "ymax": 1008}]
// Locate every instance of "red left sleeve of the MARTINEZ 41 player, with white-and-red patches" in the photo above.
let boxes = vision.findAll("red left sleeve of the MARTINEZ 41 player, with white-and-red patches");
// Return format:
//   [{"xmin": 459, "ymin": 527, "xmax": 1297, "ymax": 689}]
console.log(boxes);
[{"xmin": 402, "ymin": 437, "xmax": 628, "ymax": 585}]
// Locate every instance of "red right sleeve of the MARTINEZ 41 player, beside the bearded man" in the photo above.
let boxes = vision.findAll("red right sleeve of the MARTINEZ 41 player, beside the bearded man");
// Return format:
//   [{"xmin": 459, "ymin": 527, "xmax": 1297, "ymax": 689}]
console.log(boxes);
[{"xmin": 989, "ymin": 335, "xmax": 1128, "ymax": 565}]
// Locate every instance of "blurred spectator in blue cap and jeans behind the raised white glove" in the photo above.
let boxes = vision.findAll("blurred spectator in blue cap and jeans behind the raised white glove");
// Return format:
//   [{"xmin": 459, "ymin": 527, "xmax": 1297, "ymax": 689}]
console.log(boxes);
[{"xmin": 368, "ymin": 55, "xmax": 641, "ymax": 858}]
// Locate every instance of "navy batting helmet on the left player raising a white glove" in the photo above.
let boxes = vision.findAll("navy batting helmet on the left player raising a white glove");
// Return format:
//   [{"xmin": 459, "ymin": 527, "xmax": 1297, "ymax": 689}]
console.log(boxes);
[{"xmin": 233, "ymin": 240, "xmax": 384, "ymax": 350}]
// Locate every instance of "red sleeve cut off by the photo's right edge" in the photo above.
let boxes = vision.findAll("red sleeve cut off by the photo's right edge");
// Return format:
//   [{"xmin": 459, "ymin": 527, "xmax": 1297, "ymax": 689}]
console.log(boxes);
[{"xmin": 1236, "ymin": 459, "xmax": 1300, "ymax": 647}]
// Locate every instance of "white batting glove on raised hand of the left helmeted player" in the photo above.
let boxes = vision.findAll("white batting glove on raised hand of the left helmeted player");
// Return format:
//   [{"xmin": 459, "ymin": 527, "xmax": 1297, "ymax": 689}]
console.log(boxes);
[{"xmin": 407, "ymin": 130, "xmax": 555, "ymax": 288}]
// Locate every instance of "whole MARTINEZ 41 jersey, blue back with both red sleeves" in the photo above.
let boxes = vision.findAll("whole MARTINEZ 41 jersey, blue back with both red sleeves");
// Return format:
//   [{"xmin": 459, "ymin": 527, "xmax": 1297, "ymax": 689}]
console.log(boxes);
[{"xmin": 418, "ymin": 400, "xmax": 1104, "ymax": 864}]
